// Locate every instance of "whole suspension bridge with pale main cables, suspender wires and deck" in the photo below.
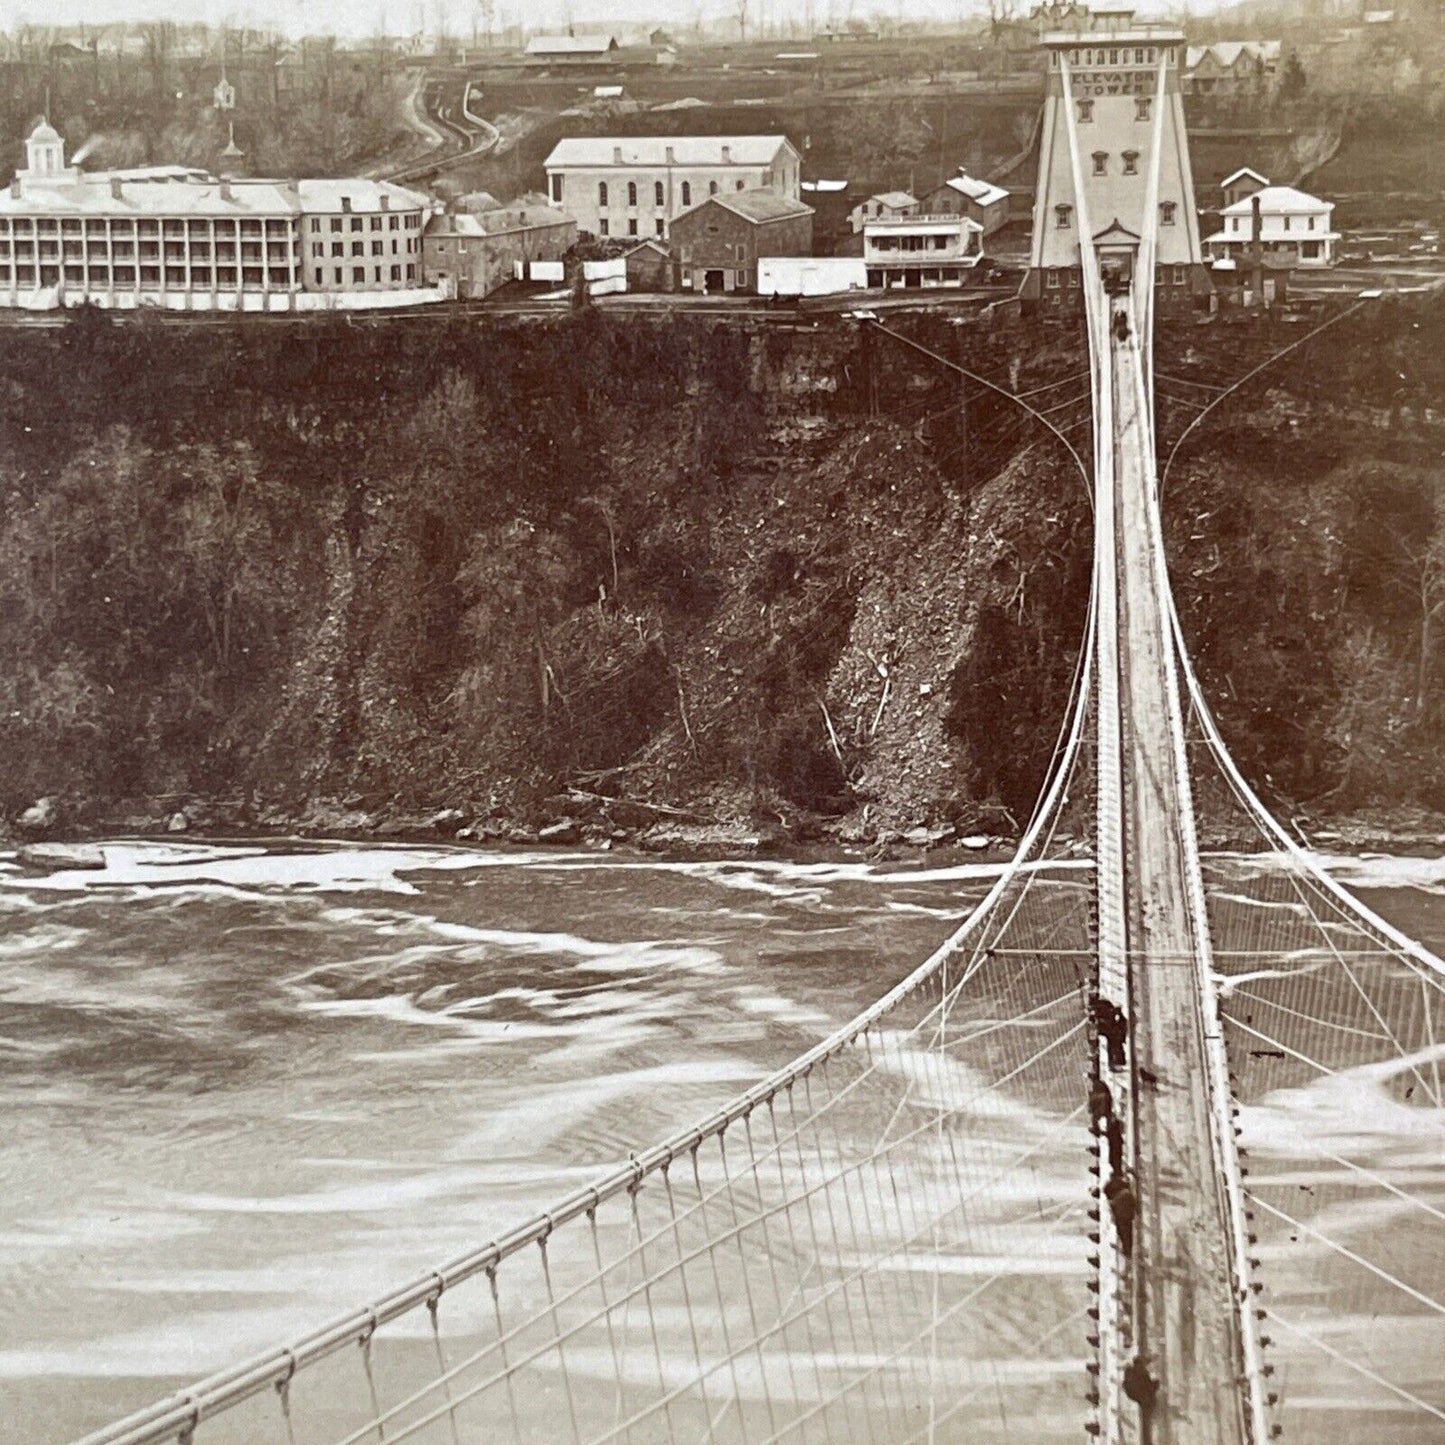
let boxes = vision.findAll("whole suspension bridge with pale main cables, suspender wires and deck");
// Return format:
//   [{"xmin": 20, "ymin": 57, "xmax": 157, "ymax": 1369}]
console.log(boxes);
[{"xmin": 76, "ymin": 56, "xmax": 1445, "ymax": 1445}]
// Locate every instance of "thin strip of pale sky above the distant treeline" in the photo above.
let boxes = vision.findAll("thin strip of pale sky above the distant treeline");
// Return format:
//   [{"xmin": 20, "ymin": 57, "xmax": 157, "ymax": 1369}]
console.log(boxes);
[{"xmin": 0, "ymin": 0, "xmax": 1199, "ymax": 36}]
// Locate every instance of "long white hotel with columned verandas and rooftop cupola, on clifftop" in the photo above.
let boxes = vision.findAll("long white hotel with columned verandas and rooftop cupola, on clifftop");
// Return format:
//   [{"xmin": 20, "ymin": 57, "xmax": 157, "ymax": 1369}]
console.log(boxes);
[{"xmin": 0, "ymin": 121, "xmax": 432, "ymax": 311}]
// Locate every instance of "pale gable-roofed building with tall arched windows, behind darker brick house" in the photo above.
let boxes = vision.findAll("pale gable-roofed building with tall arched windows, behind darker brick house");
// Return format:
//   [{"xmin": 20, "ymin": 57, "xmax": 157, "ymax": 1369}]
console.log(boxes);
[{"xmin": 546, "ymin": 136, "xmax": 811, "ymax": 241}]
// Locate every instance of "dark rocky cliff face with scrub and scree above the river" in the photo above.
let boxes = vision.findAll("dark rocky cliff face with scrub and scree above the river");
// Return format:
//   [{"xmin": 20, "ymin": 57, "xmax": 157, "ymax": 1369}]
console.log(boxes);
[{"xmin": 0, "ymin": 297, "xmax": 1441, "ymax": 835}]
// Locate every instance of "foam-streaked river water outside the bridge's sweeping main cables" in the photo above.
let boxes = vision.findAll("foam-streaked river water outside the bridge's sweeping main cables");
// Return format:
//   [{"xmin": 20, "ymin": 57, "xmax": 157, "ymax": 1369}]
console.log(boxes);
[{"xmin": 0, "ymin": 842, "xmax": 1445, "ymax": 1445}]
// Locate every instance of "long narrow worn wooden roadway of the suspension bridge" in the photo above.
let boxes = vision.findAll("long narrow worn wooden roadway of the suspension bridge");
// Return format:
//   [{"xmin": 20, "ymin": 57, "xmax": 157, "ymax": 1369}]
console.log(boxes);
[{"xmin": 1110, "ymin": 310, "xmax": 1248, "ymax": 1445}]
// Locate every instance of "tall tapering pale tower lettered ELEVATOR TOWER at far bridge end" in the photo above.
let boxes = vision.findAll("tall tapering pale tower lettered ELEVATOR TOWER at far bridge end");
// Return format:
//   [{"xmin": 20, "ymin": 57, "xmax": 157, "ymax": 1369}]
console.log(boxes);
[{"xmin": 1020, "ymin": 6, "xmax": 1212, "ymax": 308}]
